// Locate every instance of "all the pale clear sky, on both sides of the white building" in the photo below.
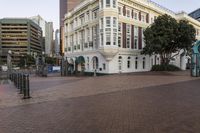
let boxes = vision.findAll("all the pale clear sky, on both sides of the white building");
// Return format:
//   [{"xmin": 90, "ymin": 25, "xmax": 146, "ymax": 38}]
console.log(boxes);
[{"xmin": 0, "ymin": 0, "xmax": 200, "ymax": 29}]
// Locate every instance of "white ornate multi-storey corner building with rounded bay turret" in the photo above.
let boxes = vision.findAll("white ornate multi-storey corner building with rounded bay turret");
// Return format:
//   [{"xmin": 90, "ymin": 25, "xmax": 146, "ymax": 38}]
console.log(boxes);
[{"xmin": 64, "ymin": 0, "xmax": 200, "ymax": 74}]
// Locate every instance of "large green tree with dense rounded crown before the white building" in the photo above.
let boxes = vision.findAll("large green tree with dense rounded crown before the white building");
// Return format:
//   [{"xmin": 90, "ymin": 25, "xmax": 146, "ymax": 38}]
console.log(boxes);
[{"xmin": 141, "ymin": 14, "xmax": 196, "ymax": 64}]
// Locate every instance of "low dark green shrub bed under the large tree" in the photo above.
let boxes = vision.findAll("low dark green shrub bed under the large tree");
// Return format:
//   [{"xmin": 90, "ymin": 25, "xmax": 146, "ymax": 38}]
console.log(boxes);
[{"xmin": 151, "ymin": 64, "xmax": 181, "ymax": 71}]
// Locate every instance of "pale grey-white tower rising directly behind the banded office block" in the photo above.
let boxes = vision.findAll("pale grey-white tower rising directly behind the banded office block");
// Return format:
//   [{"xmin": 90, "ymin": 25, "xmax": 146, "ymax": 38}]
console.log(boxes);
[{"xmin": 30, "ymin": 15, "xmax": 53, "ymax": 56}]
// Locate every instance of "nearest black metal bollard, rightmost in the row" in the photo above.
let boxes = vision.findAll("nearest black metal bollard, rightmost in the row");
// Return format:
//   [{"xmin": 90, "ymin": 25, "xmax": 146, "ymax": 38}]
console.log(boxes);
[{"xmin": 23, "ymin": 74, "xmax": 30, "ymax": 99}]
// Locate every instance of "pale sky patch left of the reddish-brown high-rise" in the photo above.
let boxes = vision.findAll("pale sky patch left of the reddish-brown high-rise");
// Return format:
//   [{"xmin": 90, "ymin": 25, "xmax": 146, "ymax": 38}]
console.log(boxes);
[{"xmin": 0, "ymin": 0, "xmax": 59, "ymax": 29}]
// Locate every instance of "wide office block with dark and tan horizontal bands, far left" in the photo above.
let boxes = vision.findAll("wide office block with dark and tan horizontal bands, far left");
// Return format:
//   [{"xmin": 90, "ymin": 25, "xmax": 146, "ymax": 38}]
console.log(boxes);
[{"xmin": 0, "ymin": 18, "xmax": 42, "ymax": 64}]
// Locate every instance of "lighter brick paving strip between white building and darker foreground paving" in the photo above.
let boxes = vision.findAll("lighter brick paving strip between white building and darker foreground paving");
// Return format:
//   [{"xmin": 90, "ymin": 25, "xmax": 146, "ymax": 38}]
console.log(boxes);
[{"xmin": 0, "ymin": 70, "xmax": 199, "ymax": 108}]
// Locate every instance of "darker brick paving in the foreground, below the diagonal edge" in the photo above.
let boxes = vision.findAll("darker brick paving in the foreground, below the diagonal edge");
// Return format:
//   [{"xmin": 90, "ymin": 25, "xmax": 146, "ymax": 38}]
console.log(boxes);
[{"xmin": 0, "ymin": 80, "xmax": 200, "ymax": 133}]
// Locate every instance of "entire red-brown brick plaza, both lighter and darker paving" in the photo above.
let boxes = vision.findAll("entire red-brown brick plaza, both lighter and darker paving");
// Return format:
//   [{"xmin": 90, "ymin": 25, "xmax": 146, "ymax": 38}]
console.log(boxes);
[{"xmin": 0, "ymin": 72, "xmax": 200, "ymax": 133}]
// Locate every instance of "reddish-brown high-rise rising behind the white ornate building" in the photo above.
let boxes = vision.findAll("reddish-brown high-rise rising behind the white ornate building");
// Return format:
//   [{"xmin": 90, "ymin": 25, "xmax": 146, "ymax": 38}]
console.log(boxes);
[{"xmin": 60, "ymin": 0, "xmax": 83, "ymax": 55}]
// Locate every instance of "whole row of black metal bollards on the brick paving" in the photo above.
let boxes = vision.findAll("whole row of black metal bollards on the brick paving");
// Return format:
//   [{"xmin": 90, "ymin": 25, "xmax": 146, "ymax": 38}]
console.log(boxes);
[{"xmin": 10, "ymin": 73, "xmax": 31, "ymax": 99}]
